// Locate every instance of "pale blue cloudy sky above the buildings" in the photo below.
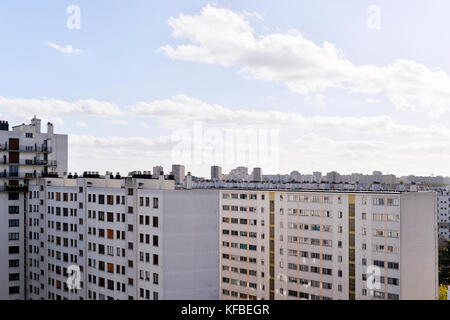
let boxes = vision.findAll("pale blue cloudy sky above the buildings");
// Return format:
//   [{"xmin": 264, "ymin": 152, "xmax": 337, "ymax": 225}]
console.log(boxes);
[{"xmin": 0, "ymin": 0, "xmax": 450, "ymax": 176}]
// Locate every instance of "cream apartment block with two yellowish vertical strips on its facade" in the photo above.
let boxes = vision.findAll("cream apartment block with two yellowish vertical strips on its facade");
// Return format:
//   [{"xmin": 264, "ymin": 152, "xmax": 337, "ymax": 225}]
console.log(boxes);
[{"xmin": 220, "ymin": 189, "xmax": 438, "ymax": 300}]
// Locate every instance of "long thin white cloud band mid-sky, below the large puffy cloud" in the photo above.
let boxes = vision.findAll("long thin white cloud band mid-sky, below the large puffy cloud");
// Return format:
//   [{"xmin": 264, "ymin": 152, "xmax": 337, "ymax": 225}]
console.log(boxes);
[{"xmin": 131, "ymin": 95, "xmax": 398, "ymax": 132}]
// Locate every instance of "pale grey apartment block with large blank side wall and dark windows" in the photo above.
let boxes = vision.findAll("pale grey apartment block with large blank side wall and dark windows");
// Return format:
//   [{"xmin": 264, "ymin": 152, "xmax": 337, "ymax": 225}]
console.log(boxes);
[{"xmin": 26, "ymin": 173, "xmax": 219, "ymax": 300}]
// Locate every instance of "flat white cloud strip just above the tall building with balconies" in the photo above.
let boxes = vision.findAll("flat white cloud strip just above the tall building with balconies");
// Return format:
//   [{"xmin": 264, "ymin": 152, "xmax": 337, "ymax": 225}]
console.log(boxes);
[{"xmin": 0, "ymin": 96, "xmax": 122, "ymax": 119}]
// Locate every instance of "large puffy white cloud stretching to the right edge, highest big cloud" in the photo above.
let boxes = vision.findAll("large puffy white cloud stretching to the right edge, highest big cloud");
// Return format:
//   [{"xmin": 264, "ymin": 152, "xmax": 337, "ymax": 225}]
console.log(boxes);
[{"xmin": 161, "ymin": 5, "xmax": 450, "ymax": 116}]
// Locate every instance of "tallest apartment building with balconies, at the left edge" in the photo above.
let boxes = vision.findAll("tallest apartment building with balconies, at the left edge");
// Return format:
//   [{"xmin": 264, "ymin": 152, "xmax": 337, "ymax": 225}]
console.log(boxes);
[{"xmin": 0, "ymin": 117, "xmax": 67, "ymax": 300}]
